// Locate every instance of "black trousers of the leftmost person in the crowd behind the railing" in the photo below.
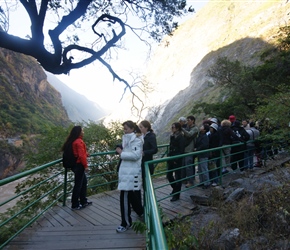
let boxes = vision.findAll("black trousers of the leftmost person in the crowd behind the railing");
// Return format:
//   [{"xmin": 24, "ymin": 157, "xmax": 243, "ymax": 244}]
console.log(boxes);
[{"xmin": 166, "ymin": 160, "xmax": 182, "ymax": 198}]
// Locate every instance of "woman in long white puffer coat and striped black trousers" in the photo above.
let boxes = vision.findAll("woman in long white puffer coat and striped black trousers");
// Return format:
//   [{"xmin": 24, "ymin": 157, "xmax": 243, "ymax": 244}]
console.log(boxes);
[{"xmin": 116, "ymin": 121, "xmax": 143, "ymax": 233}]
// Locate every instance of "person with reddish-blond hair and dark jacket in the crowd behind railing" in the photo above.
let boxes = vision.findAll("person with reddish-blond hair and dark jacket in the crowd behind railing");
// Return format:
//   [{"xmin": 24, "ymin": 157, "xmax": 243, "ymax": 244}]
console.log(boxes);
[{"xmin": 221, "ymin": 120, "xmax": 239, "ymax": 174}]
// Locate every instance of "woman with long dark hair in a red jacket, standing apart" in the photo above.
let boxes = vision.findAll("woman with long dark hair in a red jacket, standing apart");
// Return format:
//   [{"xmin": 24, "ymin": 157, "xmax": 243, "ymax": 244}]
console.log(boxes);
[{"xmin": 62, "ymin": 126, "xmax": 92, "ymax": 210}]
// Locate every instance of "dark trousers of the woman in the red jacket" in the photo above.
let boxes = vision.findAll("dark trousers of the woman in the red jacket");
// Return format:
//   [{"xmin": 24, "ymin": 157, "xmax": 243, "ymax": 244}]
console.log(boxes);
[{"xmin": 71, "ymin": 163, "xmax": 88, "ymax": 207}]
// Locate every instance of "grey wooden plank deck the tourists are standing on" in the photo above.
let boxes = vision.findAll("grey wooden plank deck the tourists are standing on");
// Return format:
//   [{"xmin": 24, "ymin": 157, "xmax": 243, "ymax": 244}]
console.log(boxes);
[{"xmin": 5, "ymin": 177, "xmax": 206, "ymax": 250}]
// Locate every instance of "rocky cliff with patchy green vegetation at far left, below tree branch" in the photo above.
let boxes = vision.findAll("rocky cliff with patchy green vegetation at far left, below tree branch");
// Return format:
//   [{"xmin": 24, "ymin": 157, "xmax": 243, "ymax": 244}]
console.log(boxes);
[{"xmin": 0, "ymin": 49, "xmax": 70, "ymax": 179}]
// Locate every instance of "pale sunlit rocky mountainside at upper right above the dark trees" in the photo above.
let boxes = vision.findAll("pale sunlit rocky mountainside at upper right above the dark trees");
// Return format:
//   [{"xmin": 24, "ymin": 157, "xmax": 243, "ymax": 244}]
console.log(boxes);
[{"xmin": 146, "ymin": 0, "xmax": 290, "ymax": 142}]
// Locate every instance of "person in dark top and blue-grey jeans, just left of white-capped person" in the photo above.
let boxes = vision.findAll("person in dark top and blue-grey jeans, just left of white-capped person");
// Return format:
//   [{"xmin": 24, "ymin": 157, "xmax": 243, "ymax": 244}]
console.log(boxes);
[{"xmin": 194, "ymin": 124, "xmax": 210, "ymax": 189}]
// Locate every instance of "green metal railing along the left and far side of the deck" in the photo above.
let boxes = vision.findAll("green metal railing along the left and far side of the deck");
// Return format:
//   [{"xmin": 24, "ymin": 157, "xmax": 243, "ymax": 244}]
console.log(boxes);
[{"xmin": 0, "ymin": 145, "xmax": 168, "ymax": 249}]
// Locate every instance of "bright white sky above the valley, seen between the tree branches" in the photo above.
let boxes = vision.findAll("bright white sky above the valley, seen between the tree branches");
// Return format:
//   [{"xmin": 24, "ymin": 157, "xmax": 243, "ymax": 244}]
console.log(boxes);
[{"xmin": 6, "ymin": 0, "xmax": 208, "ymax": 111}]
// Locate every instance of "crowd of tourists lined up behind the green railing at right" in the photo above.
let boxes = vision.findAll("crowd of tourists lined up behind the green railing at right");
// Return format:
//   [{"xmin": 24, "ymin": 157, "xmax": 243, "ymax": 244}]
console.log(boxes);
[{"xmin": 167, "ymin": 115, "xmax": 260, "ymax": 202}]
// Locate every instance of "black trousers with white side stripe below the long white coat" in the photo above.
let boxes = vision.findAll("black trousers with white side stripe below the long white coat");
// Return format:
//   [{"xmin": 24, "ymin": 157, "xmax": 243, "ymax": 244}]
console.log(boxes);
[{"xmin": 120, "ymin": 190, "xmax": 143, "ymax": 227}]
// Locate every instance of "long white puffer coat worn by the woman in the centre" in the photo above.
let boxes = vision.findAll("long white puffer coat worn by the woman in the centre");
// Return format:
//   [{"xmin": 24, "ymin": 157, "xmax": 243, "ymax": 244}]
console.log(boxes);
[{"xmin": 118, "ymin": 133, "xmax": 143, "ymax": 191}]
